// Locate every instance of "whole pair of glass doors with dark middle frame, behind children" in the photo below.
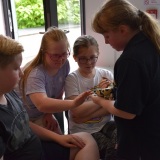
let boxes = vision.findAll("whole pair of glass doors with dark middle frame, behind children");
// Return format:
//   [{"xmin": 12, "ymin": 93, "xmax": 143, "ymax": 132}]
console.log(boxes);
[{"xmin": 6, "ymin": 0, "xmax": 83, "ymax": 135}]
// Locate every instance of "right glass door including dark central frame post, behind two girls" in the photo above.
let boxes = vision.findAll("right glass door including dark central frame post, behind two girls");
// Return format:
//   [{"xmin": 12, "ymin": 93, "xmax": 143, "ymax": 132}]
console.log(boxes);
[{"xmin": 43, "ymin": 0, "xmax": 84, "ymax": 71}]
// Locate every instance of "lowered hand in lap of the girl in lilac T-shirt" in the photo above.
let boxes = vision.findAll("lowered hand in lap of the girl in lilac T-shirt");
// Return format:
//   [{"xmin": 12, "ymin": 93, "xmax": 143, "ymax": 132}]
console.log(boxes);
[{"xmin": 43, "ymin": 113, "xmax": 62, "ymax": 134}]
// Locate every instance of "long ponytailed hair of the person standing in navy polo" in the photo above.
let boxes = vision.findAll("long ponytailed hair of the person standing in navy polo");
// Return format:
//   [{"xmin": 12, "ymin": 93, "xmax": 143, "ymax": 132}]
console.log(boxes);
[{"xmin": 92, "ymin": 0, "xmax": 160, "ymax": 50}]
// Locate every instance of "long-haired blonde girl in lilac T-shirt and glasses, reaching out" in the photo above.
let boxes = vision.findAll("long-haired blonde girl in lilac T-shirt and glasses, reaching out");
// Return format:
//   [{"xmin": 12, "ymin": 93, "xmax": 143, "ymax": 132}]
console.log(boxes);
[{"xmin": 20, "ymin": 27, "xmax": 80, "ymax": 134}]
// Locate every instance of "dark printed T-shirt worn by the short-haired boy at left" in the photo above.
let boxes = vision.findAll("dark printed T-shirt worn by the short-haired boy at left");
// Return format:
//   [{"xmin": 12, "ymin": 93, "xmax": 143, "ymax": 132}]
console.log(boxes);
[{"xmin": 0, "ymin": 92, "xmax": 42, "ymax": 160}]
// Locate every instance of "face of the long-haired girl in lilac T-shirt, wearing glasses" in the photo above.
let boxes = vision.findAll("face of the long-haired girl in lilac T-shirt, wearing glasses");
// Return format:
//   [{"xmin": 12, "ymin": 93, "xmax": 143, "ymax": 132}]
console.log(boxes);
[{"xmin": 45, "ymin": 40, "xmax": 70, "ymax": 70}]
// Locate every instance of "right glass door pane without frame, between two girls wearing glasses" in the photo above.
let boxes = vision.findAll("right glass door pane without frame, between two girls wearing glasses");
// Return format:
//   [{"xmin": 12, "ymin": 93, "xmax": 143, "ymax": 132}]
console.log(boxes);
[{"xmin": 57, "ymin": 0, "xmax": 81, "ymax": 71}]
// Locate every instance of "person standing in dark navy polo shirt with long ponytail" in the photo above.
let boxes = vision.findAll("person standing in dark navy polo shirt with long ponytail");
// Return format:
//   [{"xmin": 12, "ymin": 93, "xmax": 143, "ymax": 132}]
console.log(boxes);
[{"xmin": 91, "ymin": 0, "xmax": 160, "ymax": 160}]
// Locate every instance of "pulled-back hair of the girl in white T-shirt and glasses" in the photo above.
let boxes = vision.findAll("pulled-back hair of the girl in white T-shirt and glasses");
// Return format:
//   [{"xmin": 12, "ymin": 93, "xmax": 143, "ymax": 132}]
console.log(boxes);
[{"xmin": 73, "ymin": 35, "xmax": 99, "ymax": 56}]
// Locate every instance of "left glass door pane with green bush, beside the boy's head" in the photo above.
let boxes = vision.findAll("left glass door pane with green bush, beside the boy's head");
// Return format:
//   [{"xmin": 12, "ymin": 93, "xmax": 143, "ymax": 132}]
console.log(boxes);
[{"xmin": 11, "ymin": 0, "xmax": 45, "ymax": 67}]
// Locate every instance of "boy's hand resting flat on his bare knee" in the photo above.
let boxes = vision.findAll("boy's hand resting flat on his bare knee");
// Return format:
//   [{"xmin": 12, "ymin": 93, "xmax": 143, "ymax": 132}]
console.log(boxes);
[{"xmin": 58, "ymin": 134, "xmax": 85, "ymax": 148}]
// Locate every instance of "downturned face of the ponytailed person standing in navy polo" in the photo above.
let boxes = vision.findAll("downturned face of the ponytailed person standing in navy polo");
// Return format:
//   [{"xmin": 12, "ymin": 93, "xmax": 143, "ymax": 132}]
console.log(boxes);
[{"xmin": 103, "ymin": 26, "xmax": 128, "ymax": 51}]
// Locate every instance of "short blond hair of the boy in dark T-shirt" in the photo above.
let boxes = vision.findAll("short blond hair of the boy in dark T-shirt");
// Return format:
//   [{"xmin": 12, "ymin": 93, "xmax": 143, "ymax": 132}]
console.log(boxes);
[{"xmin": 0, "ymin": 35, "xmax": 24, "ymax": 68}]
